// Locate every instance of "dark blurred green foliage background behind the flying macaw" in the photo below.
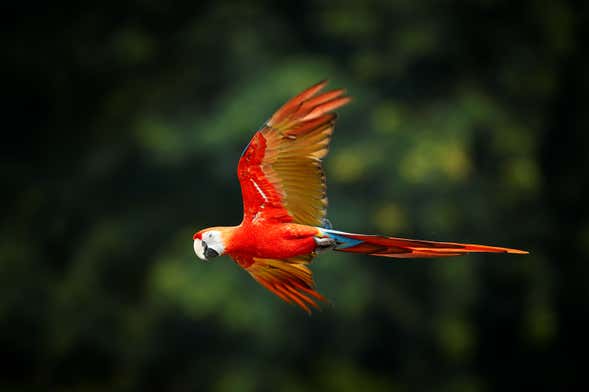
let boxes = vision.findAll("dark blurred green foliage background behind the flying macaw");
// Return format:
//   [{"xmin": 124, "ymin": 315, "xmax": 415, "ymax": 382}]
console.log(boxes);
[{"xmin": 0, "ymin": 0, "xmax": 589, "ymax": 391}]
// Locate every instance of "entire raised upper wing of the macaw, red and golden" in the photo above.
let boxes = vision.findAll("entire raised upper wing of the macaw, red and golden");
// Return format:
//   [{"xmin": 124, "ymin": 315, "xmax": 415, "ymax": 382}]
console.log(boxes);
[{"xmin": 237, "ymin": 81, "xmax": 350, "ymax": 226}]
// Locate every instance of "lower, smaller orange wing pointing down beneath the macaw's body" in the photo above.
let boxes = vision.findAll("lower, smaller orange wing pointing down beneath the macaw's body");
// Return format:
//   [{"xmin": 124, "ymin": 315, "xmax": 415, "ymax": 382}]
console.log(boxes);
[{"xmin": 236, "ymin": 257, "xmax": 325, "ymax": 313}]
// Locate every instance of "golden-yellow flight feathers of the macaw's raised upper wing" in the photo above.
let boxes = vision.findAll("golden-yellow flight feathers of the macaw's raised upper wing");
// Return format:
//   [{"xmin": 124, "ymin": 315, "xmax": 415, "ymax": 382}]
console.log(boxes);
[{"xmin": 252, "ymin": 81, "xmax": 350, "ymax": 226}]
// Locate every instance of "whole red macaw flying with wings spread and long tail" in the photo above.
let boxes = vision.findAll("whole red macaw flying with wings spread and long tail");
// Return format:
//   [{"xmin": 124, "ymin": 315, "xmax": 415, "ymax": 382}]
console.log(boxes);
[{"xmin": 193, "ymin": 81, "xmax": 528, "ymax": 312}]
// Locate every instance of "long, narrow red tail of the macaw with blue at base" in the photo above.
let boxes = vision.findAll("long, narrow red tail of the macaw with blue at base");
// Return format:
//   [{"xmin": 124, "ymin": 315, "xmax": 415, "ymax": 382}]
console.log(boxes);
[{"xmin": 322, "ymin": 229, "xmax": 529, "ymax": 259}]
